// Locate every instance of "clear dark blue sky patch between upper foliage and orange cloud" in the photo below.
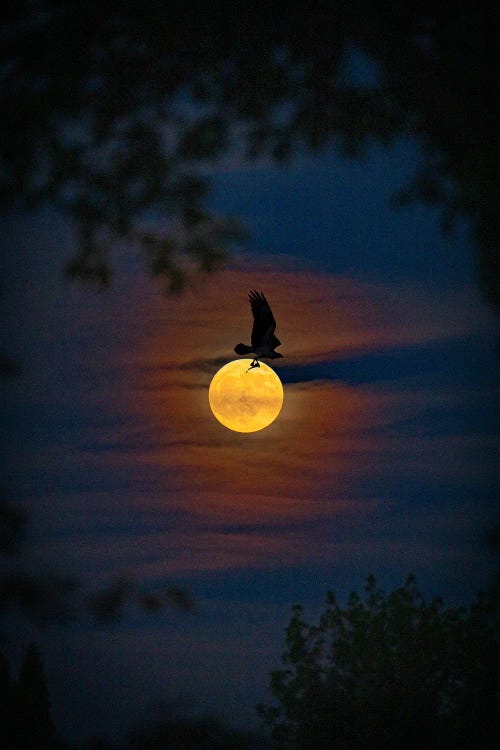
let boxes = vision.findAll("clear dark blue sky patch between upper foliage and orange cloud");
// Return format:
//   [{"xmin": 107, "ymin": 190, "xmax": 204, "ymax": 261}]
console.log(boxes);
[{"xmin": 213, "ymin": 139, "xmax": 475, "ymax": 288}]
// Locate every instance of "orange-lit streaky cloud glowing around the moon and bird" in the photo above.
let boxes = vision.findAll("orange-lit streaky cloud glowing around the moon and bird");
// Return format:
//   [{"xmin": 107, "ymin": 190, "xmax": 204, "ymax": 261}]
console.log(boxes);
[{"xmin": 69, "ymin": 256, "xmax": 481, "ymax": 572}]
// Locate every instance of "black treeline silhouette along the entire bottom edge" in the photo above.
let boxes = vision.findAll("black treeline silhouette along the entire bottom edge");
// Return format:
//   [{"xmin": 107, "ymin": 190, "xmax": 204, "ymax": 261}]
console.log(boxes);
[{"xmin": 0, "ymin": 575, "xmax": 500, "ymax": 750}]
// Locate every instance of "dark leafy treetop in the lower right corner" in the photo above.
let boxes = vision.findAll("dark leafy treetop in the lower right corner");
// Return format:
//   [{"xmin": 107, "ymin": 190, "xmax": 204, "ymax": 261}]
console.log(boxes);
[{"xmin": 259, "ymin": 576, "xmax": 499, "ymax": 750}]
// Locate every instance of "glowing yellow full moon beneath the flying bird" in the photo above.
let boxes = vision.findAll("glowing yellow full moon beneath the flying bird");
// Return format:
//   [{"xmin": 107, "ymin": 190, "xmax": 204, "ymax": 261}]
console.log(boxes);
[{"xmin": 208, "ymin": 359, "xmax": 283, "ymax": 432}]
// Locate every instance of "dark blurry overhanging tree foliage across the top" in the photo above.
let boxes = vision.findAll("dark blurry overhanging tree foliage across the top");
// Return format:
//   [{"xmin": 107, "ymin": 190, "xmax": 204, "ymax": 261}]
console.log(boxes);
[{"xmin": 0, "ymin": 0, "xmax": 500, "ymax": 303}]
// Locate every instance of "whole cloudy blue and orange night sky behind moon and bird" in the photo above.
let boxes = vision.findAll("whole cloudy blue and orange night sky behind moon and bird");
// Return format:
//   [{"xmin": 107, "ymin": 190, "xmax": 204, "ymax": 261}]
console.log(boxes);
[{"xmin": 1, "ymin": 137, "xmax": 498, "ymax": 739}]
